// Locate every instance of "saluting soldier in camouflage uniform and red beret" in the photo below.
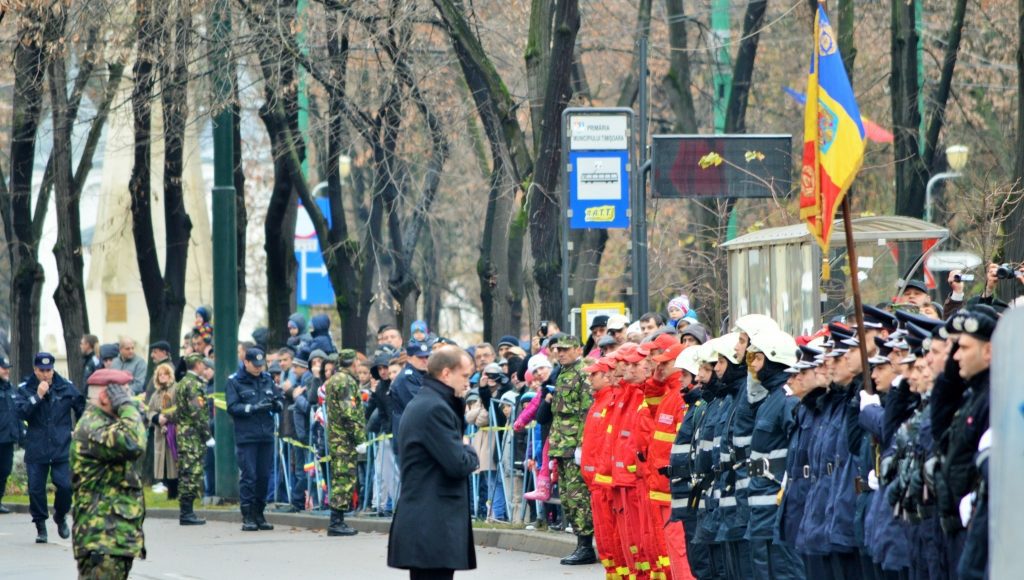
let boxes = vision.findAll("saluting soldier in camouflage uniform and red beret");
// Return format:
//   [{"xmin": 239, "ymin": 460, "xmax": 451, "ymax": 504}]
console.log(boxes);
[{"xmin": 71, "ymin": 369, "xmax": 146, "ymax": 580}]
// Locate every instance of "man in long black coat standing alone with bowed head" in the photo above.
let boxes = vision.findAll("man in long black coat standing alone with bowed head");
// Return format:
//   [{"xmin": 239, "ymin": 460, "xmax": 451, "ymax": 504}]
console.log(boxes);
[{"xmin": 387, "ymin": 346, "xmax": 479, "ymax": 580}]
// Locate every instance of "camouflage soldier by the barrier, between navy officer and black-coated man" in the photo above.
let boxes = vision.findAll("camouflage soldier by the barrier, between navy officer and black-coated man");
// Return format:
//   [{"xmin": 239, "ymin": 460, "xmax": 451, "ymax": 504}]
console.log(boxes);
[{"xmin": 324, "ymin": 348, "xmax": 365, "ymax": 536}]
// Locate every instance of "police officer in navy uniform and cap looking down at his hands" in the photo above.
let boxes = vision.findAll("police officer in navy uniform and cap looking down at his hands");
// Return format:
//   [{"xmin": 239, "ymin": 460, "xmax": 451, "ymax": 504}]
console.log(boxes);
[{"xmin": 225, "ymin": 347, "xmax": 284, "ymax": 532}]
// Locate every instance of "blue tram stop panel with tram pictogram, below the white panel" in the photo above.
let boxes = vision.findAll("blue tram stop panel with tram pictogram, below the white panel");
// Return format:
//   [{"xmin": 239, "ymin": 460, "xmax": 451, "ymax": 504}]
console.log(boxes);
[{"xmin": 567, "ymin": 150, "xmax": 630, "ymax": 230}]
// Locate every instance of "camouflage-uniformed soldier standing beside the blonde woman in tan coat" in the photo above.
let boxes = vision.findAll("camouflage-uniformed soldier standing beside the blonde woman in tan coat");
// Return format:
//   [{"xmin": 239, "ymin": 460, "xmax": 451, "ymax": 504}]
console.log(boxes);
[{"xmin": 174, "ymin": 354, "xmax": 210, "ymax": 526}]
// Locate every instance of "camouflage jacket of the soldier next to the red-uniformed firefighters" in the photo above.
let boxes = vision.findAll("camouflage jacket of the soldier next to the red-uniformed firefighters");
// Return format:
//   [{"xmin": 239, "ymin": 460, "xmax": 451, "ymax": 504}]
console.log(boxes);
[{"xmin": 548, "ymin": 360, "xmax": 593, "ymax": 457}]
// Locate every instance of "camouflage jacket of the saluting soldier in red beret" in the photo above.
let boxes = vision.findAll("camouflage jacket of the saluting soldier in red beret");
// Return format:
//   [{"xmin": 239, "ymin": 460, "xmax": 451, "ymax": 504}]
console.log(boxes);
[{"xmin": 71, "ymin": 403, "xmax": 146, "ymax": 558}]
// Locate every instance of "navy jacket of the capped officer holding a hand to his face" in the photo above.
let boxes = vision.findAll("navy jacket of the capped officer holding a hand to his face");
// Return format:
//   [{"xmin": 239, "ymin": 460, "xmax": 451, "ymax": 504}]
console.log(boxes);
[{"xmin": 17, "ymin": 373, "xmax": 85, "ymax": 463}]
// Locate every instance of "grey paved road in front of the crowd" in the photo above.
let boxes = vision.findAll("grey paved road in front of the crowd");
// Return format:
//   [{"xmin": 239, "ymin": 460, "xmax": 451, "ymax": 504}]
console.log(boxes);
[{"xmin": 0, "ymin": 513, "xmax": 603, "ymax": 580}]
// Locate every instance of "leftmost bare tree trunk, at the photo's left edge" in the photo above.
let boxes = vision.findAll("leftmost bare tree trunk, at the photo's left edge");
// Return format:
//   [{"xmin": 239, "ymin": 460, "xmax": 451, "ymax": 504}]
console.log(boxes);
[{"xmin": 0, "ymin": 10, "xmax": 46, "ymax": 379}]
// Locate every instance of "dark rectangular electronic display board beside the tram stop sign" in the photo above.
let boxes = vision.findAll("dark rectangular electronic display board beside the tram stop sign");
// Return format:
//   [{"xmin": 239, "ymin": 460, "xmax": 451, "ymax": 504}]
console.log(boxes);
[{"xmin": 651, "ymin": 135, "xmax": 793, "ymax": 198}]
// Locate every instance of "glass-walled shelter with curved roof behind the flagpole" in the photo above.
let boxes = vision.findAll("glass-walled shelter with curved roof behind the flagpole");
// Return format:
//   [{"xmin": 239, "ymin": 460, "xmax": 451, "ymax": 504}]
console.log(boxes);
[{"xmin": 722, "ymin": 216, "xmax": 949, "ymax": 336}]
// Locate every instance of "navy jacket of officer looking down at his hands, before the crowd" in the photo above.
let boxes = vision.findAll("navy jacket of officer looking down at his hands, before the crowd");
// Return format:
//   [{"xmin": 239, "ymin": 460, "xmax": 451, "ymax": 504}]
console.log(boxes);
[{"xmin": 225, "ymin": 370, "xmax": 284, "ymax": 444}]
